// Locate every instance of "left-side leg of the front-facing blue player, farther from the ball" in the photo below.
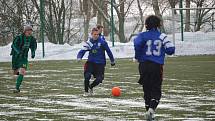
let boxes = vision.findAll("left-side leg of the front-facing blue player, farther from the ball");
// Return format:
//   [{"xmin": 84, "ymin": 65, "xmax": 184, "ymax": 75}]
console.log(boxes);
[{"xmin": 84, "ymin": 62, "xmax": 93, "ymax": 93}]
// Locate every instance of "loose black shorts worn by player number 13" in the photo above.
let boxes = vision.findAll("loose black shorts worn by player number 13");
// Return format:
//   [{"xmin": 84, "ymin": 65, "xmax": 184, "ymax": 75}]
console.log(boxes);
[{"xmin": 138, "ymin": 61, "xmax": 163, "ymax": 86}]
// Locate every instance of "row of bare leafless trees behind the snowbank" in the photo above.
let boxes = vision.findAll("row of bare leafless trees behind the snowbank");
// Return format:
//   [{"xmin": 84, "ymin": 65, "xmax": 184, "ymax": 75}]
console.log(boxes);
[{"xmin": 0, "ymin": 0, "xmax": 215, "ymax": 45}]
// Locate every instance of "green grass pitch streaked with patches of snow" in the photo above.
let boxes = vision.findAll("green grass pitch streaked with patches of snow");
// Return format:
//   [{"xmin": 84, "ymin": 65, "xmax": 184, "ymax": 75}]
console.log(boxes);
[{"xmin": 0, "ymin": 56, "xmax": 215, "ymax": 121}]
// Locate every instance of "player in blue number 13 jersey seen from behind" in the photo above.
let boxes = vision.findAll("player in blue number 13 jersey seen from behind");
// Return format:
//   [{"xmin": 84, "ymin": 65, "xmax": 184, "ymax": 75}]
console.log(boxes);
[{"xmin": 134, "ymin": 15, "xmax": 175, "ymax": 121}]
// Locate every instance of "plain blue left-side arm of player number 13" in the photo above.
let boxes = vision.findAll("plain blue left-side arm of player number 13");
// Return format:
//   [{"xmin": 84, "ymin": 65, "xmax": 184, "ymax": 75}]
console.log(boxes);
[{"xmin": 134, "ymin": 33, "xmax": 144, "ymax": 60}]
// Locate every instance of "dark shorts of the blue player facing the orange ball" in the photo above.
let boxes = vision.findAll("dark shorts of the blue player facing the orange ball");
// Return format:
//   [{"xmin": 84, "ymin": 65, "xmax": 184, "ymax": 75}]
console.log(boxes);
[{"xmin": 84, "ymin": 61, "xmax": 105, "ymax": 79}]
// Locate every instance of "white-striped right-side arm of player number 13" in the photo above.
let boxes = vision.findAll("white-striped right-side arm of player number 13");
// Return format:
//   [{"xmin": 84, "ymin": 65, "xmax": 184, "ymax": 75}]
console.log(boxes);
[{"xmin": 163, "ymin": 36, "xmax": 175, "ymax": 55}]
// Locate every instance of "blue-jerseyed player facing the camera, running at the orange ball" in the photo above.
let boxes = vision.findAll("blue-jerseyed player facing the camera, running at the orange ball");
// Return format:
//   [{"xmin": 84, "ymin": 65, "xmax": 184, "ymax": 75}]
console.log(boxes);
[{"xmin": 77, "ymin": 28, "xmax": 115, "ymax": 96}]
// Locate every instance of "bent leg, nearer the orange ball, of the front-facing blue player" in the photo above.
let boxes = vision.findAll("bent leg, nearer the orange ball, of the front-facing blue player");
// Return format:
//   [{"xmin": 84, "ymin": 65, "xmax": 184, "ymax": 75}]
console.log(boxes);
[{"xmin": 90, "ymin": 64, "xmax": 105, "ymax": 89}]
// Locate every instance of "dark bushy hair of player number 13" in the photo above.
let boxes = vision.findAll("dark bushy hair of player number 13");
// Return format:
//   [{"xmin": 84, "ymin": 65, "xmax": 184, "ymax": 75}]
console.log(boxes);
[{"xmin": 145, "ymin": 15, "xmax": 161, "ymax": 30}]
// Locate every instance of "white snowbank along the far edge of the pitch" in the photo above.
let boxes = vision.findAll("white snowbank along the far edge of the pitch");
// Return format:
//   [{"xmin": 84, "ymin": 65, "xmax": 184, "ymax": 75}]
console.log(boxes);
[{"xmin": 0, "ymin": 32, "xmax": 215, "ymax": 62}]
